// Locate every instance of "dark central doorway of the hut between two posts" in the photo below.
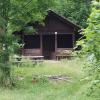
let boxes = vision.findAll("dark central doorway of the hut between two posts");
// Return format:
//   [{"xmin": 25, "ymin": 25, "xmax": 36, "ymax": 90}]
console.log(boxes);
[{"xmin": 42, "ymin": 34, "xmax": 55, "ymax": 59}]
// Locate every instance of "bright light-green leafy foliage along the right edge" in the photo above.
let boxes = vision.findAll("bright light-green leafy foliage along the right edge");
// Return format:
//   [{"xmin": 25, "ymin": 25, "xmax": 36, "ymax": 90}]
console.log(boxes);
[{"xmin": 79, "ymin": 1, "xmax": 100, "ymax": 95}]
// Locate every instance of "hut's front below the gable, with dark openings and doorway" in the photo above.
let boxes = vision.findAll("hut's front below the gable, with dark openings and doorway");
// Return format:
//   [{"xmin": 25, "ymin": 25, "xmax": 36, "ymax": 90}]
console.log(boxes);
[{"xmin": 23, "ymin": 33, "xmax": 73, "ymax": 59}]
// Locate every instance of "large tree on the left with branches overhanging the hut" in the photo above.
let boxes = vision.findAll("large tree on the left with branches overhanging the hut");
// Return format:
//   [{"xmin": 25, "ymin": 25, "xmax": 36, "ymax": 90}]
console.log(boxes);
[{"xmin": 0, "ymin": 0, "xmax": 53, "ymax": 86}]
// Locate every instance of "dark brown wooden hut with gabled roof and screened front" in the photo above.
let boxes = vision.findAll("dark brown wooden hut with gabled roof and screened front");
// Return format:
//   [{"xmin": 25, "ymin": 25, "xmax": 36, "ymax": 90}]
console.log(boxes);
[{"xmin": 16, "ymin": 10, "xmax": 80, "ymax": 59}]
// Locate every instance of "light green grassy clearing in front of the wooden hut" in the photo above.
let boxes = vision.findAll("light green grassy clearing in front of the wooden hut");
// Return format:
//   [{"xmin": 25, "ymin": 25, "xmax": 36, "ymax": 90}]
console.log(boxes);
[{"xmin": 0, "ymin": 59, "xmax": 100, "ymax": 100}]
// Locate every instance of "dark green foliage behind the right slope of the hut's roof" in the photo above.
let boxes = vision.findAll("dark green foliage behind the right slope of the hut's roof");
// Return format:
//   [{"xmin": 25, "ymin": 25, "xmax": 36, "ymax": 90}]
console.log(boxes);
[{"xmin": 55, "ymin": 0, "xmax": 91, "ymax": 27}]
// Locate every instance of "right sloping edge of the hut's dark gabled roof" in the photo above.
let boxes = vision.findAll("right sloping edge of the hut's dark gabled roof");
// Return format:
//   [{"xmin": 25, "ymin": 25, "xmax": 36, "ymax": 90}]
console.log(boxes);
[{"xmin": 48, "ymin": 9, "xmax": 81, "ymax": 30}]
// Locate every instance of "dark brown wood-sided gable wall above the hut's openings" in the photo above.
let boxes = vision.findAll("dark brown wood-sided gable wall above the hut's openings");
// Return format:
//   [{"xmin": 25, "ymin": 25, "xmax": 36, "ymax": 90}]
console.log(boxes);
[{"xmin": 38, "ymin": 13, "xmax": 74, "ymax": 34}]
